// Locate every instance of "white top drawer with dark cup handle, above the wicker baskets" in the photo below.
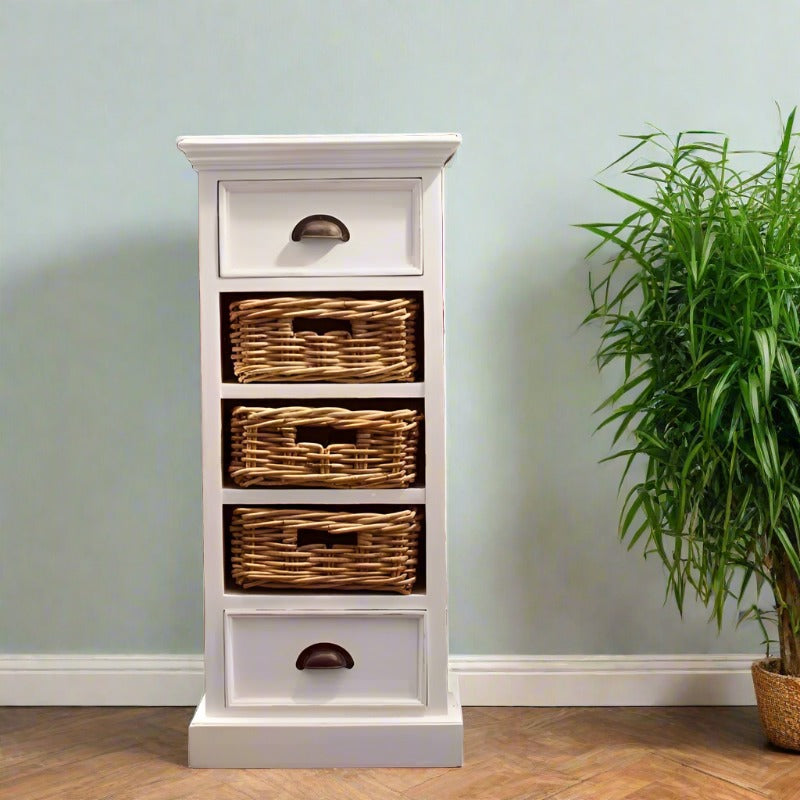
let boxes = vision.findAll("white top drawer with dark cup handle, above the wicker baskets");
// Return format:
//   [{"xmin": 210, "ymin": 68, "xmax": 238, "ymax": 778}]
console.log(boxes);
[{"xmin": 219, "ymin": 178, "xmax": 422, "ymax": 278}]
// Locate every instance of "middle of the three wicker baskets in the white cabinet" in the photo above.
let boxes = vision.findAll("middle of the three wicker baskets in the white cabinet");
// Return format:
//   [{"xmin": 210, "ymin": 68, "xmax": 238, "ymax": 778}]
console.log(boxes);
[{"xmin": 229, "ymin": 406, "xmax": 422, "ymax": 488}]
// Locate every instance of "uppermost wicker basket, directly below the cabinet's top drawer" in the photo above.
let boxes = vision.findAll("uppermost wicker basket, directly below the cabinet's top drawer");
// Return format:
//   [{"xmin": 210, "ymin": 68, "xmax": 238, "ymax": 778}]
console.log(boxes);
[{"xmin": 230, "ymin": 297, "xmax": 418, "ymax": 383}]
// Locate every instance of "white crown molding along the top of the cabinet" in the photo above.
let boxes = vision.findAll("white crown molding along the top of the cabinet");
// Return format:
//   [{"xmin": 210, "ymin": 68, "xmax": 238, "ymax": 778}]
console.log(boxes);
[{"xmin": 177, "ymin": 133, "xmax": 461, "ymax": 171}]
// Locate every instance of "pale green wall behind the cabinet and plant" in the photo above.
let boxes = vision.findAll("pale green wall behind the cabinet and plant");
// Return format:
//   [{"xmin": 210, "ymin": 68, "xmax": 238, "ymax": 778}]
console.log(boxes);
[{"xmin": 0, "ymin": 0, "xmax": 800, "ymax": 653}]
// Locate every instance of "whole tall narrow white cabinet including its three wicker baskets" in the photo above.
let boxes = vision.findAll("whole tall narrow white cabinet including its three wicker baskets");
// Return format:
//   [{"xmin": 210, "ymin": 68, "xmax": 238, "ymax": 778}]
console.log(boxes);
[{"xmin": 178, "ymin": 134, "xmax": 463, "ymax": 767}]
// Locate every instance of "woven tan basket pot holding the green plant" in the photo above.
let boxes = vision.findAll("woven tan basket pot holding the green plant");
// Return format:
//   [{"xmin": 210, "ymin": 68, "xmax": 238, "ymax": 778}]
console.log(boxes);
[{"xmin": 751, "ymin": 658, "xmax": 800, "ymax": 751}]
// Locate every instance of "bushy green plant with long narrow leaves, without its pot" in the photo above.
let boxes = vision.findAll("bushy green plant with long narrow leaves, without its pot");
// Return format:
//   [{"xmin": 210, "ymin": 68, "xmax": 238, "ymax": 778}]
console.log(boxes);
[{"xmin": 579, "ymin": 111, "xmax": 800, "ymax": 676}]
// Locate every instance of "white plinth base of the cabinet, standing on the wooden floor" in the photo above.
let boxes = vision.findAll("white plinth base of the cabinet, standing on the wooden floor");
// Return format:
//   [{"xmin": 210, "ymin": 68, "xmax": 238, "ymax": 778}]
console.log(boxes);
[{"xmin": 189, "ymin": 694, "xmax": 464, "ymax": 769}]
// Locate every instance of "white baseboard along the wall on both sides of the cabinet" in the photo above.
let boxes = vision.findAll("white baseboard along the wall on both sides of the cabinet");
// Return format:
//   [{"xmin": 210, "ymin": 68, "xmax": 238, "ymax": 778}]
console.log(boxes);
[{"xmin": 0, "ymin": 655, "xmax": 759, "ymax": 706}]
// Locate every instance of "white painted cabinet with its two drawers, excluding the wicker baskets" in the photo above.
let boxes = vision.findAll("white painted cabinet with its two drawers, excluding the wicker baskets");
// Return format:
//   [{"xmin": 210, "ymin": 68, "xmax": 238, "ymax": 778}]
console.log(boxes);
[{"xmin": 178, "ymin": 134, "xmax": 462, "ymax": 767}]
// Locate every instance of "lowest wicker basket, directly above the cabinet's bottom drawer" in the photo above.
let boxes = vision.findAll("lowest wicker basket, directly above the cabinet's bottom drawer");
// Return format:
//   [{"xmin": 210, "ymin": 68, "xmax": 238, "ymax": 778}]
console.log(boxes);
[{"xmin": 231, "ymin": 508, "xmax": 422, "ymax": 594}]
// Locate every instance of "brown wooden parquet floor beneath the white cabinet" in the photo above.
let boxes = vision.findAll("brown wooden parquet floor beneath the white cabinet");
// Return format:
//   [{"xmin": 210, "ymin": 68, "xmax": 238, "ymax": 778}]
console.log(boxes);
[{"xmin": 0, "ymin": 708, "xmax": 800, "ymax": 800}]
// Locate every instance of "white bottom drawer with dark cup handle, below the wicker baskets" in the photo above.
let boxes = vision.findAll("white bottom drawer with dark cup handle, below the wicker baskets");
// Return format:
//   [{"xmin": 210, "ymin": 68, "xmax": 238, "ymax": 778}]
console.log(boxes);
[{"xmin": 225, "ymin": 610, "xmax": 427, "ymax": 707}]
